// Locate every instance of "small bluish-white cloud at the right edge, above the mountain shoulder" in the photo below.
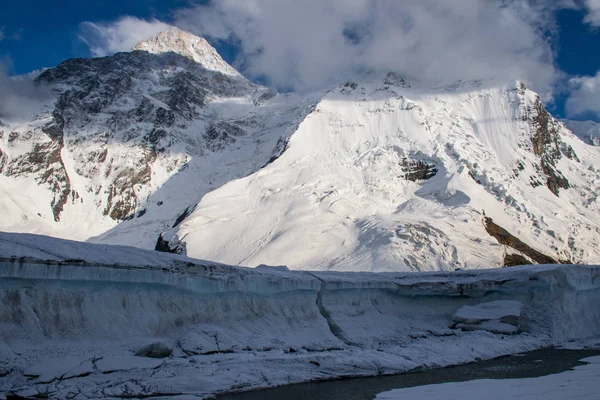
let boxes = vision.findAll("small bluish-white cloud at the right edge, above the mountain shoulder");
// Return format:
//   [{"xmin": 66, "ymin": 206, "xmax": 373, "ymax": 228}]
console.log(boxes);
[{"xmin": 565, "ymin": 70, "xmax": 600, "ymax": 120}]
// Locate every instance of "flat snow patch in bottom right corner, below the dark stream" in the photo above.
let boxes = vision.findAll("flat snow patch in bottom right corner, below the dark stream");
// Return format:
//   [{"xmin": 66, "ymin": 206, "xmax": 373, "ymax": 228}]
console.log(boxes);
[{"xmin": 376, "ymin": 357, "xmax": 600, "ymax": 400}]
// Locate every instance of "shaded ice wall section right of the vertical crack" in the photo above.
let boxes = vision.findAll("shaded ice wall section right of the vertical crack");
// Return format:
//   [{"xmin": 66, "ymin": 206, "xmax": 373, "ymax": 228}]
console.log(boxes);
[{"xmin": 314, "ymin": 265, "xmax": 600, "ymax": 350}]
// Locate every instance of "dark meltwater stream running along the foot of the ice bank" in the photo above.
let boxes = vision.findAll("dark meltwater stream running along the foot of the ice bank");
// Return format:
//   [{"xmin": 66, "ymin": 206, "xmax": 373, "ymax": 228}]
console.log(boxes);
[{"xmin": 217, "ymin": 348, "xmax": 600, "ymax": 400}]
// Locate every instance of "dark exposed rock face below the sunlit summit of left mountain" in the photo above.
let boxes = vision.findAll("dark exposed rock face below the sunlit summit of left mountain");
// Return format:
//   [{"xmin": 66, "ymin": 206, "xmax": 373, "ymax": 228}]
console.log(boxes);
[{"xmin": 18, "ymin": 51, "xmax": 255, "ymax": 220}]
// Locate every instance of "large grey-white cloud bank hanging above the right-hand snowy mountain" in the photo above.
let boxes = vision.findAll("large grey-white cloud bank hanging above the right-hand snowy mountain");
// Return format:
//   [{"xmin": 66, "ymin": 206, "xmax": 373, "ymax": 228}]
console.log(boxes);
[{"xmin": 176, "ymin": 0, "xmax": 574, "ymax": 91}]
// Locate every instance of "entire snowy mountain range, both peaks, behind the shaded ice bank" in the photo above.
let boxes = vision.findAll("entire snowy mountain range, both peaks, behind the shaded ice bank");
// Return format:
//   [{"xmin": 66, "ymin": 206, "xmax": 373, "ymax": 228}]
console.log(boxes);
[{"xmin": 0, "ymin": 28, "xmax": 600, "ymax": 271}]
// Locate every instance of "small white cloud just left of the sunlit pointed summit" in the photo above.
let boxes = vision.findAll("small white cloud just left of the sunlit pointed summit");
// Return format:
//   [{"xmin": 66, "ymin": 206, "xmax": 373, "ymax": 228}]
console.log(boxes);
[{"xmin": 79, "ymin": 17, "xmax": 169, "ymax": 57}]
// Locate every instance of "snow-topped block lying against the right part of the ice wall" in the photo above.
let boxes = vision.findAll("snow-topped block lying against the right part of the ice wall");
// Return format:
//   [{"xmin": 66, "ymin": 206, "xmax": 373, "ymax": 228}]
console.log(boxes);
[{"xmin": 450, "ymin": 300, "xmax": 523, "ymax": 334}]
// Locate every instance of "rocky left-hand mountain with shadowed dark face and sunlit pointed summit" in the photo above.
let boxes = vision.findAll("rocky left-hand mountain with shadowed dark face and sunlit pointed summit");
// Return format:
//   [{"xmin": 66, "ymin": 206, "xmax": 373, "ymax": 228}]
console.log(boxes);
[{"xmin": 0, "ymin": 28, "xmax": 316, "ymax": 245}]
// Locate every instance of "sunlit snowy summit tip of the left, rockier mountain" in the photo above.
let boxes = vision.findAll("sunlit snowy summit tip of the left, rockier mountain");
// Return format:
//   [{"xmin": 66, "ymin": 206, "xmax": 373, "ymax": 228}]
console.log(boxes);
[{"xmin": 134, "ymin": 26, "xmax": 241, "ymax": 76}]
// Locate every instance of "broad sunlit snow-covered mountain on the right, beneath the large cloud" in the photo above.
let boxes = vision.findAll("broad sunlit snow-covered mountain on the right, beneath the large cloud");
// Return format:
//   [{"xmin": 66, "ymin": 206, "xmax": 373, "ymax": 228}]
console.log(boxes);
[{"xmin": 163, "ymin": 74, "xmax": 600, "ymax": 271}]
